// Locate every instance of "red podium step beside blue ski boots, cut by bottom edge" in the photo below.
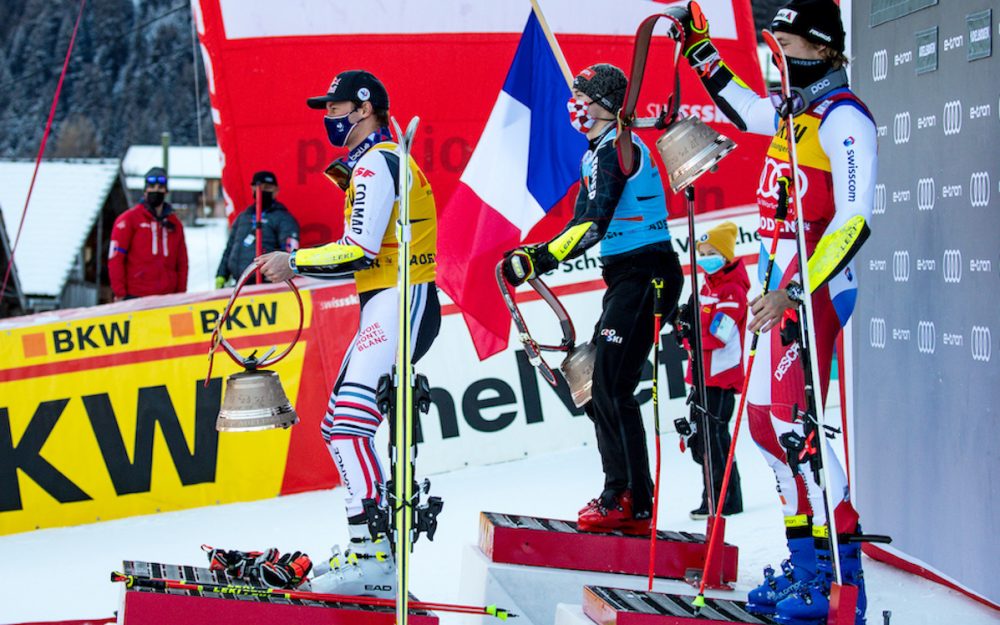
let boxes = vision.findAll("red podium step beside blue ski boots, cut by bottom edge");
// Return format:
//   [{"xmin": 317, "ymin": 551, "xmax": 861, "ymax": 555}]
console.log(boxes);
[{"xmin": 583, "ymin": 586, "xmax": 774, "ymax": 625}]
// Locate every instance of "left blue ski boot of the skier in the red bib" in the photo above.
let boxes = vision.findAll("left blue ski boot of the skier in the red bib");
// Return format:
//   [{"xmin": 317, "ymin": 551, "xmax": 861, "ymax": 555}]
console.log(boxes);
[{"xmin": 746, "ymin": 514, "xmax": 816, "ymax": 616}]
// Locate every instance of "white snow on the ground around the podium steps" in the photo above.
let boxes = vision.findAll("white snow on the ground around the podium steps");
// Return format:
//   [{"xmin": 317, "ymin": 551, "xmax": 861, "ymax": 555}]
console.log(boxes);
[{"xmin": 0, "ymin": 426, "xmax": 1000, "ymax": 625}]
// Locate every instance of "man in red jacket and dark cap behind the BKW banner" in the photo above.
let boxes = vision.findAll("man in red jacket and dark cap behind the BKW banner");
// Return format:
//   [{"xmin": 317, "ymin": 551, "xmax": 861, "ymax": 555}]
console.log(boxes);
[{"xmin": 108, "ymin": 167, "xmax": 188, "ymax": 301}]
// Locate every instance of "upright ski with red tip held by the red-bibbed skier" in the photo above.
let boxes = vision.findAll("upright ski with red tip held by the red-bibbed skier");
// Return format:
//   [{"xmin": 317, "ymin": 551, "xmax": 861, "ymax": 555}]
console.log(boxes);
[{"xmin": 761, "ymin": 30, "xmax": 843, "ymax": 585}]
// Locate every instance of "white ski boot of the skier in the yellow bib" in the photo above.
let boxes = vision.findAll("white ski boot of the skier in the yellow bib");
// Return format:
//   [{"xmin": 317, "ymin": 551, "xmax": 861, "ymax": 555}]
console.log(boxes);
[{"xmin": 310, "ymin": 525, "xmax": 396, "ymax": 599}]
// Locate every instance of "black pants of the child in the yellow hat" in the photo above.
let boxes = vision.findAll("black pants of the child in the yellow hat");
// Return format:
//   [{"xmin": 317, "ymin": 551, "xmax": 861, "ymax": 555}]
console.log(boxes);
[{"xmin": 688, "ymin": 386, "xmax": 743, "ymax": 514}]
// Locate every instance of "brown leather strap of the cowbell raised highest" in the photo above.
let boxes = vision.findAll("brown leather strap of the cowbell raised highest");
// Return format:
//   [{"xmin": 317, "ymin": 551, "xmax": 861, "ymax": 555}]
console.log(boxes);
[{"xmin": 615, "ymin": 13, "xmax": 684, "ymax": 175}]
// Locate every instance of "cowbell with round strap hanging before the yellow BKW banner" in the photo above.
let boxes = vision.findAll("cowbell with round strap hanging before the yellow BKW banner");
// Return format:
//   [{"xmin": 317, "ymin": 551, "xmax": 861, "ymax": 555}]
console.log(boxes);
[{"xmin": 205, "ymin": 263, "xmax": 305, "ymax": 432}]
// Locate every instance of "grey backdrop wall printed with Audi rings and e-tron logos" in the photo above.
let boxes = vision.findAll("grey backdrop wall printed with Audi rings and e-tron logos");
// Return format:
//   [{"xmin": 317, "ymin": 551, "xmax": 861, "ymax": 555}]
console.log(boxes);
[{"xmin": 851, "ymin": 0, "xmax": 1000, "ymax": 603}]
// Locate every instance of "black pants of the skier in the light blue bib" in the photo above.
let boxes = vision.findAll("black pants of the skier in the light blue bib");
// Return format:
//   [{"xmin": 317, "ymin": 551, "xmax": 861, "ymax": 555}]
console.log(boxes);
[{"xmin": 585, "ymin": 250, "xmax": 684, "ymax": 515}]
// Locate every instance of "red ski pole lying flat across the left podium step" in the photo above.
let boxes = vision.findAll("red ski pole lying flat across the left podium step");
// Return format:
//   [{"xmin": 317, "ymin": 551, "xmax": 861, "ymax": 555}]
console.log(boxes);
[{"xmin": 111, "ymin": 571, "xmax": 517, "ymax": 621}]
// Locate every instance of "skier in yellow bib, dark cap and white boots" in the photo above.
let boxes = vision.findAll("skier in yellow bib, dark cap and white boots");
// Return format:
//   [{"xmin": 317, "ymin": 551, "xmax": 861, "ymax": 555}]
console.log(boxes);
[{"xmin": 259, "ymin": 70, "xmax": 441, "ymax": 597}]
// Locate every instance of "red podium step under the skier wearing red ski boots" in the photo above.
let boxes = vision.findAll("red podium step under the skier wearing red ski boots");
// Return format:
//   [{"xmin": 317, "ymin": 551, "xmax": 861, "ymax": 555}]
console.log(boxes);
[{"xmin": 479, "ymin": 512, "xmax": 739, "ymax": 582}]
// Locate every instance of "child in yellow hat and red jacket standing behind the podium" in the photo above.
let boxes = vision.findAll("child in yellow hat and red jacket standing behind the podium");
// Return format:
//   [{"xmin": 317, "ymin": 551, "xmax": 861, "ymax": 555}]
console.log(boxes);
[{"xmin": 675, "ymin": 221, "xmax": 750, "ymax": 519}]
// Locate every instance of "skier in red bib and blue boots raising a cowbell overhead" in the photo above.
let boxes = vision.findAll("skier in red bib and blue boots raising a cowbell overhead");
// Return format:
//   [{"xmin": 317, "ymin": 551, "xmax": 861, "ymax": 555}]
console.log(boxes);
[{"xmin": 668, "ymin": 0, "xmax": 877, "ymax": 625}]
